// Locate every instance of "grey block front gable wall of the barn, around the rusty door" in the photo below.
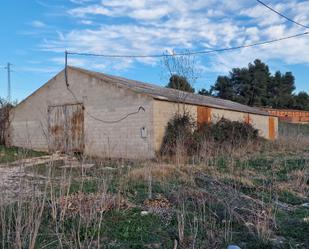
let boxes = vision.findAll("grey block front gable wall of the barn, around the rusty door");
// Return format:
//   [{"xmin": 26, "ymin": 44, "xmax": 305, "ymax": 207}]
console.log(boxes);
[{"xmin": 10, "ymin": 68, "xmax": 154, "ymax": 158}]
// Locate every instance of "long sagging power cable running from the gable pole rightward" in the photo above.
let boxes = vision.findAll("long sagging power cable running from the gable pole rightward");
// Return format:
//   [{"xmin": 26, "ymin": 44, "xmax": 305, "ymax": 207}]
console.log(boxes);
[{"xmin": 66, "ymin": 30, "xmax": 309, "ymax": 58}]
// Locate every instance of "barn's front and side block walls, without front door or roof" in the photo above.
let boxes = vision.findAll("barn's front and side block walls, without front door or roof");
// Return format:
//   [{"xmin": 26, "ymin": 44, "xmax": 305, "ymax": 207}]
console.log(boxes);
[{"xmin": 9, "ymin": 68, "xmax": 278, "ymax": 159}]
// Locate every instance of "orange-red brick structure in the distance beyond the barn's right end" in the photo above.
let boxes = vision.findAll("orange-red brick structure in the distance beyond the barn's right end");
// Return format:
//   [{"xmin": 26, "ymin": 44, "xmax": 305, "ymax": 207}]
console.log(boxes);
[{"xmin": 263, "ymin": 108, "xmax": 309, "ymax": 124}]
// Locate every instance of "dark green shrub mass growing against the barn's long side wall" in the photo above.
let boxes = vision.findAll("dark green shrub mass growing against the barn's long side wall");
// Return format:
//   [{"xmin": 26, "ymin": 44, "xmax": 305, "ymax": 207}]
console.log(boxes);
[{"xmin": 161, "ymin": 114, "xmax": 259, "ymax": 155}]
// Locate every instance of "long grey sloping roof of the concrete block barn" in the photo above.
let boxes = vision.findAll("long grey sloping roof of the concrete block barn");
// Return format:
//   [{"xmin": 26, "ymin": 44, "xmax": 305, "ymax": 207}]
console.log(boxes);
[{"xmin": 69, "ymin": 66, "xmax": 269, "ymax": 116}]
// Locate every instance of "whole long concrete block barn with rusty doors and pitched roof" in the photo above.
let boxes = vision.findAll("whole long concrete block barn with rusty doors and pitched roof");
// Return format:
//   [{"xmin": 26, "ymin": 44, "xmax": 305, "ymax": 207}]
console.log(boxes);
[{"xmin": 7, "ymin": 67, "xmax": 278, "ymax": 159}]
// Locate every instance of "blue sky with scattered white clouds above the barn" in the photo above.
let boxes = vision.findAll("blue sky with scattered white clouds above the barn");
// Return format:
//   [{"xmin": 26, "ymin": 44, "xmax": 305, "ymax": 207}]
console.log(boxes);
[{"xmin": 0, "ymin": 0, "xmax": 309, "ymax": 100}]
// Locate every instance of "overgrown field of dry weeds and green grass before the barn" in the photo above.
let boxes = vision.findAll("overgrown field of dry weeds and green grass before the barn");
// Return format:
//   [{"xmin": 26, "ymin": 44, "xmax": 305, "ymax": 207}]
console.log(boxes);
[{"xmin": 0, "ymin": 126, "xmax": 309, "ymax": 249}]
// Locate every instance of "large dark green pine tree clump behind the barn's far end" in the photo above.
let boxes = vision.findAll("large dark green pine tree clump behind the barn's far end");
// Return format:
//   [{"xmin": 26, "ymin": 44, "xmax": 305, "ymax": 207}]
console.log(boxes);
[{"xmin": 211, "ymin": 59, "xmax": 306, "ymax": 109}]
